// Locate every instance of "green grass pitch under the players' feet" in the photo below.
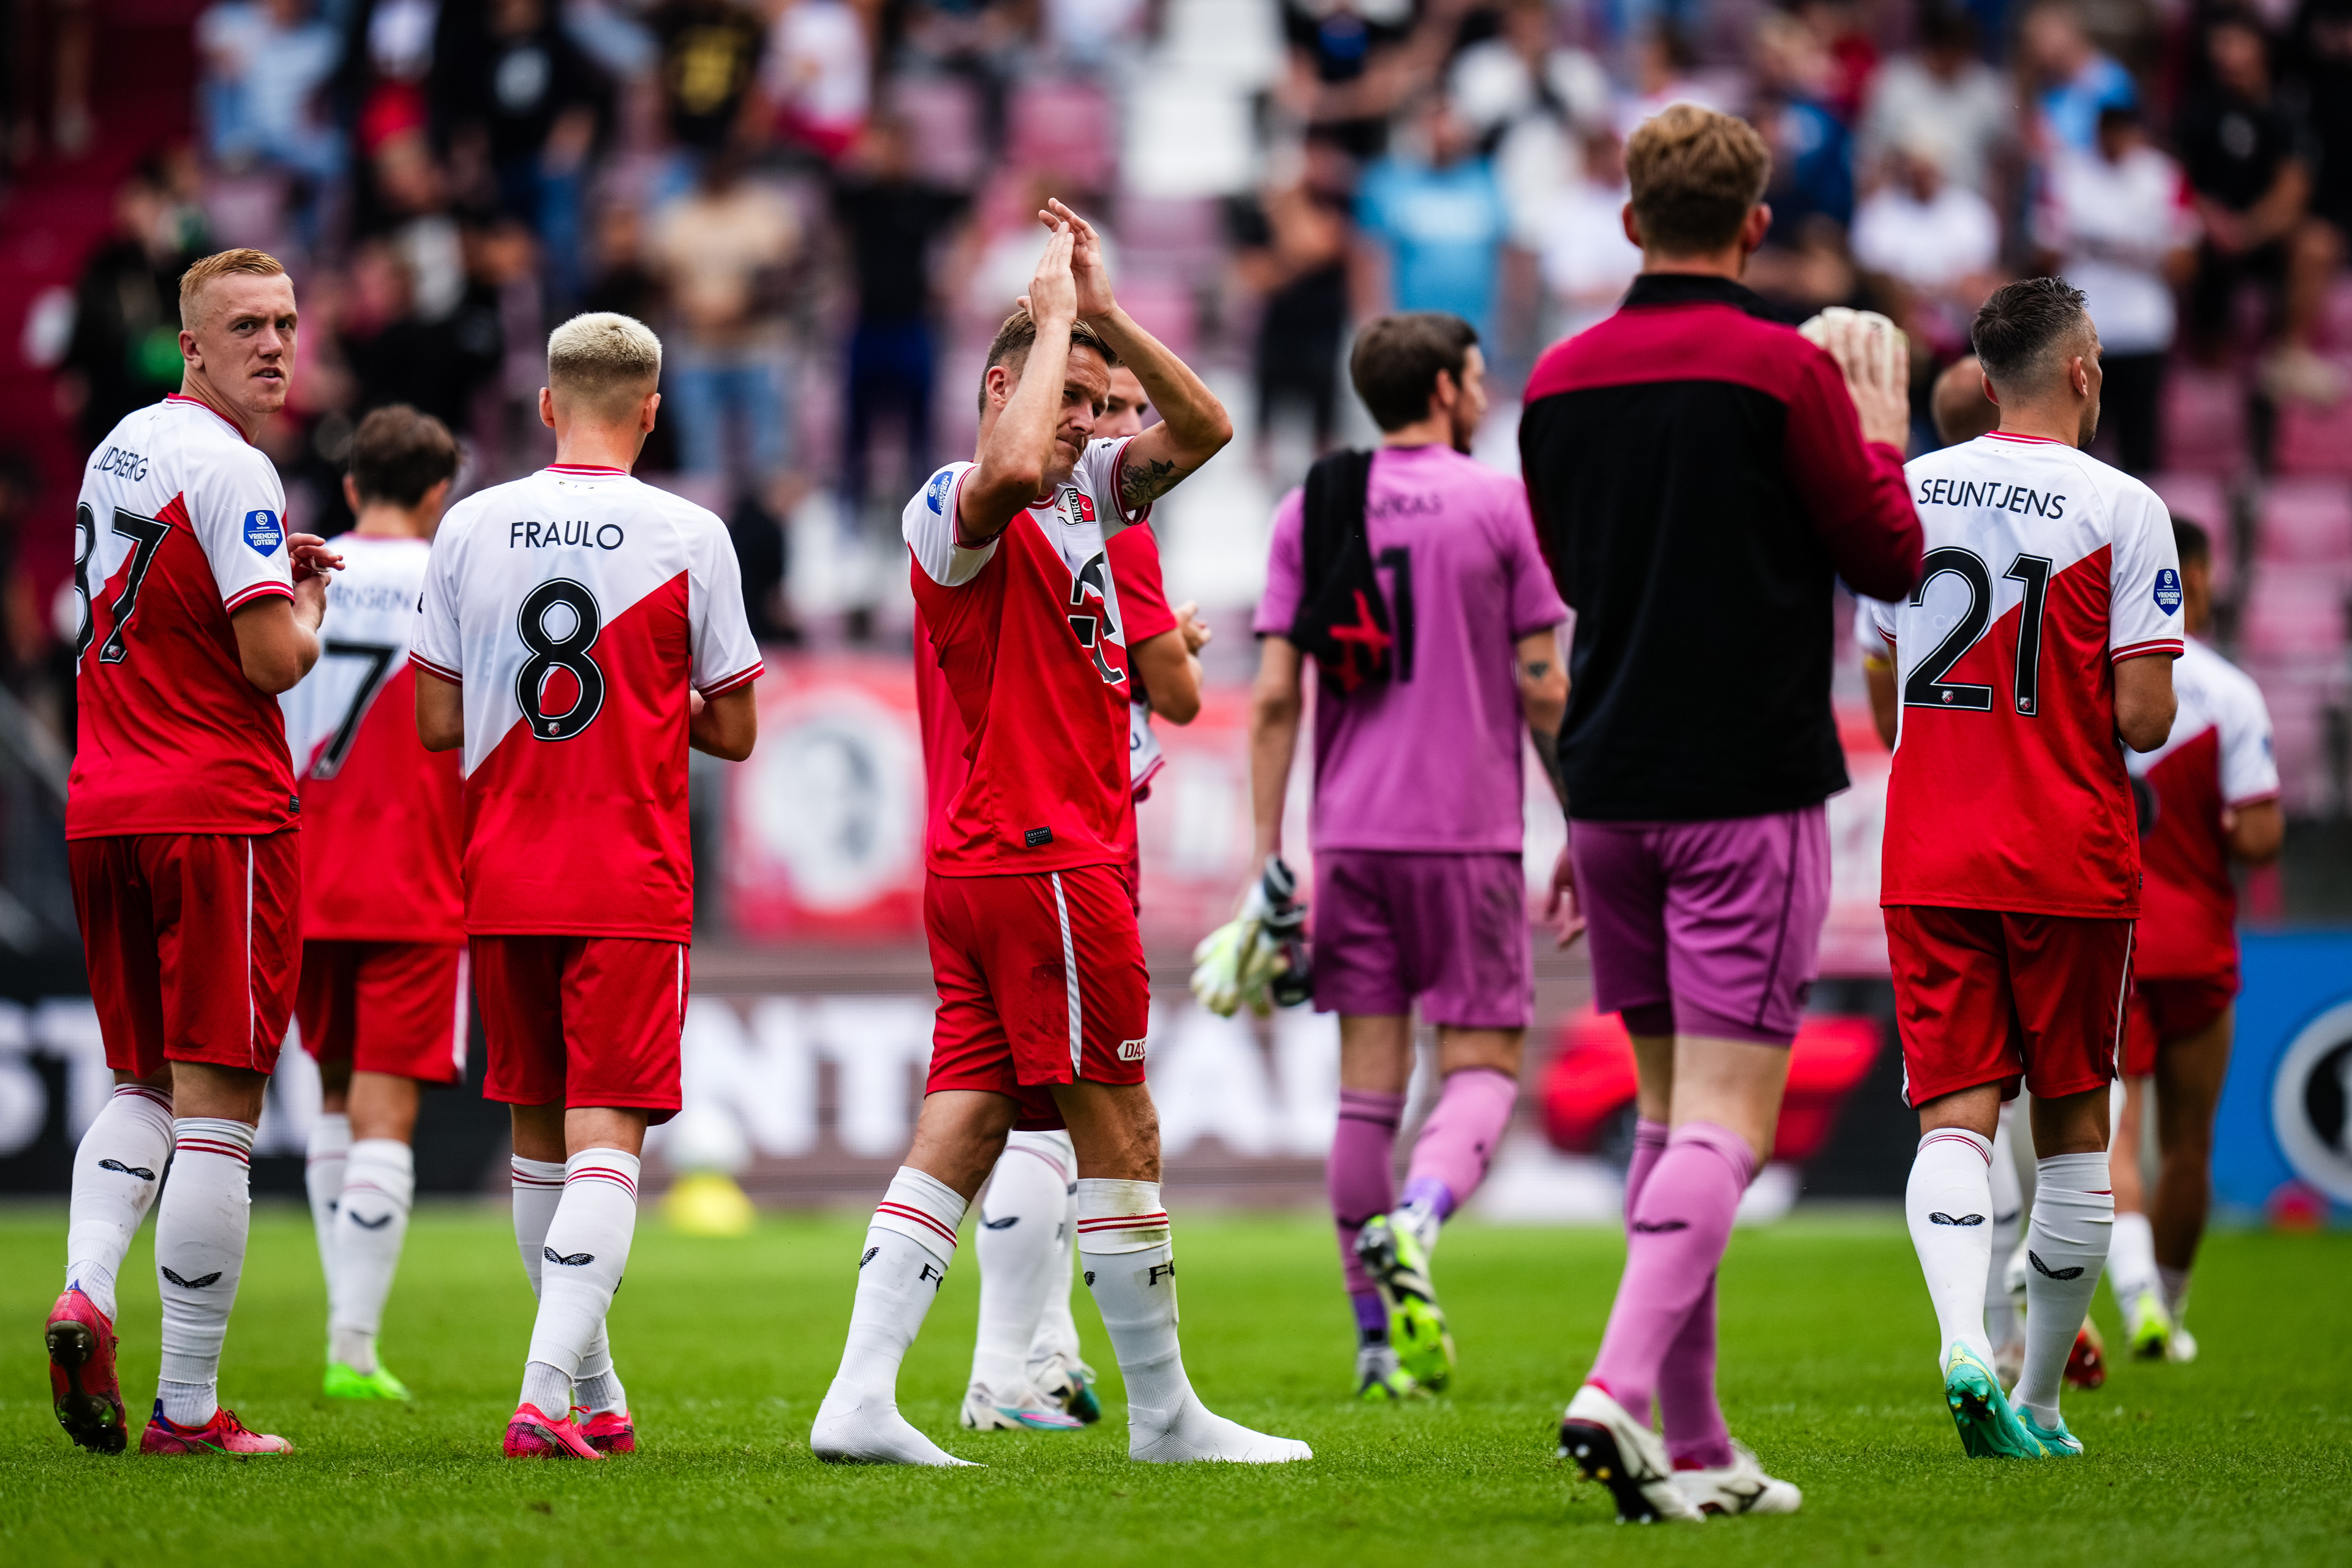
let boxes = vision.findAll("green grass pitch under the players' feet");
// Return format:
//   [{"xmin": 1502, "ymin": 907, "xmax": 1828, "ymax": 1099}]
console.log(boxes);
[{"xmin": 0, "ymin": 1208, "xmax": 2352, "ymax": 1568}]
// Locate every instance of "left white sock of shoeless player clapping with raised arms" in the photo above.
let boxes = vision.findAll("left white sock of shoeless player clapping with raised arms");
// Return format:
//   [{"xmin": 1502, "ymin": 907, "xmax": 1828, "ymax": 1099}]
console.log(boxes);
[{"xmin": 809, "ymin": 1166, "xmax": 964, "ymax": 1464}]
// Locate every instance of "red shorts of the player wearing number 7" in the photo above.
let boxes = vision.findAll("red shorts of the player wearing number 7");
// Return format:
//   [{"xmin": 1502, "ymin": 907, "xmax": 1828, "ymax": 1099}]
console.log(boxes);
[{"xmin": 294, "ymin": 943, "xmax": 468, "ymax": 1084}]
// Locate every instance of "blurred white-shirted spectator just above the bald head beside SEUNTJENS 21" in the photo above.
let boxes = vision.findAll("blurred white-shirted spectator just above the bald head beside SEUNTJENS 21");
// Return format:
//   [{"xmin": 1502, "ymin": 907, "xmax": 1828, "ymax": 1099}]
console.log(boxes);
[{"xmin": 1853, "ymin": 132, "xmax": 2002, "ymax": 355}]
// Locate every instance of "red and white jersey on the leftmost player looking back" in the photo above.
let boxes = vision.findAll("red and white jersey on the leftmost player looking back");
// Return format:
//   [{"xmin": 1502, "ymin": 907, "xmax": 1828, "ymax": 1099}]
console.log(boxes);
[{"xmin": 66, "ymin": 393, "xmax": 301, "ymax": 839}]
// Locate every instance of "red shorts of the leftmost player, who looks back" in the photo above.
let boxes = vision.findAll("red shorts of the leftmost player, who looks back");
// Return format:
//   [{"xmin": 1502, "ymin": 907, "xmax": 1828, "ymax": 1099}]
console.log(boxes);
[{"xmin": 66, "ymin": 827, "xmax": 301, "ymax": 1077}]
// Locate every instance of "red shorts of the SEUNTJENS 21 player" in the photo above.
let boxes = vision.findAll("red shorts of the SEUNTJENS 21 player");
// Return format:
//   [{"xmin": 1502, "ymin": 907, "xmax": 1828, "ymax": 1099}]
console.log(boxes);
[{"xmin": 1887, "ymin": 905, "xmax": 2133, "ymax": 1105}]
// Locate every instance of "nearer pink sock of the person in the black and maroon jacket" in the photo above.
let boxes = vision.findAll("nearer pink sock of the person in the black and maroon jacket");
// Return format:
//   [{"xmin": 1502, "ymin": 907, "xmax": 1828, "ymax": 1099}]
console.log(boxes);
[{"xmin": 1588, "ymin": 1121, "xmax": 1755, "ymax": 1420}]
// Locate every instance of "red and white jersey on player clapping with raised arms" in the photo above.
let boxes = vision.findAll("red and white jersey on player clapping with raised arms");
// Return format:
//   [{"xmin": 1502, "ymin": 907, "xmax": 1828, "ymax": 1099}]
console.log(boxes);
[{"xmin": 901, "ymin": 440, "xmax": 1134, "ymax": 877}]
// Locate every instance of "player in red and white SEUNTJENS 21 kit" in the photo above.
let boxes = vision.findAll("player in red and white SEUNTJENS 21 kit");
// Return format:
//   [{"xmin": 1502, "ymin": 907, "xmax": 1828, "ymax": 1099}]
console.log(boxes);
[{"xmin": 1872, "ymin": 277, "xmax": 2180, "ymax": 1458}]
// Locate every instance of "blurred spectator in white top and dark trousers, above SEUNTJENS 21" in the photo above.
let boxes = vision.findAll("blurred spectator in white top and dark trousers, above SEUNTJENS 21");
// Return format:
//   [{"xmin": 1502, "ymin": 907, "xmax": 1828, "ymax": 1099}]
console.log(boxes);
[{"xmin": 2035, "ymin": 108, "xmax": 2199, "ymax": 475}]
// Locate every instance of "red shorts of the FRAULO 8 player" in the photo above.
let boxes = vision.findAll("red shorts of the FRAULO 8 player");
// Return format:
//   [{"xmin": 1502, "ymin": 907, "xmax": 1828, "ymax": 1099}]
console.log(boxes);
[{"xmin": 470, "ymin": 936, "xmax": 689, "ymax": 1126}]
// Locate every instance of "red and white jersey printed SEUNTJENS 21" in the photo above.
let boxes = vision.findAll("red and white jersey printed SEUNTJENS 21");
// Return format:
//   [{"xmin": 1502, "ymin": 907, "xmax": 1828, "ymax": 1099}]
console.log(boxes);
[{"xmin": 1853, "ymin": 432, "xmax": 2180, "ymax": 919}]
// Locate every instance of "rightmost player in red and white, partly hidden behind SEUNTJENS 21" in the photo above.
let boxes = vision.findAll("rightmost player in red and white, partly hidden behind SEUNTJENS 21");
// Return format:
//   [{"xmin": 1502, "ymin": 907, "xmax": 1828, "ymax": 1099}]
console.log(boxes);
[{"xmin": 2108, "ymin": 519, "xmax": 2286, "ymax": 1361}]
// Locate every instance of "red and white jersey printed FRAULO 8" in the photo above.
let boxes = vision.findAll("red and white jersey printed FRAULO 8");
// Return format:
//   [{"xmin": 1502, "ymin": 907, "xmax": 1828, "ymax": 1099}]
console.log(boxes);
[{"xmin": 409, "ymin": 466, "xmax": 762, "ymax": 943}]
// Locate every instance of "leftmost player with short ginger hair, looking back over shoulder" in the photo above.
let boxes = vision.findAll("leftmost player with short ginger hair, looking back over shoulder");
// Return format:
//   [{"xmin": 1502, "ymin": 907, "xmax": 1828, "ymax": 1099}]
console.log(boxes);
[{"xmin": 45, "ymin": 249, "xmax": 336, "ymax": 1455}]
